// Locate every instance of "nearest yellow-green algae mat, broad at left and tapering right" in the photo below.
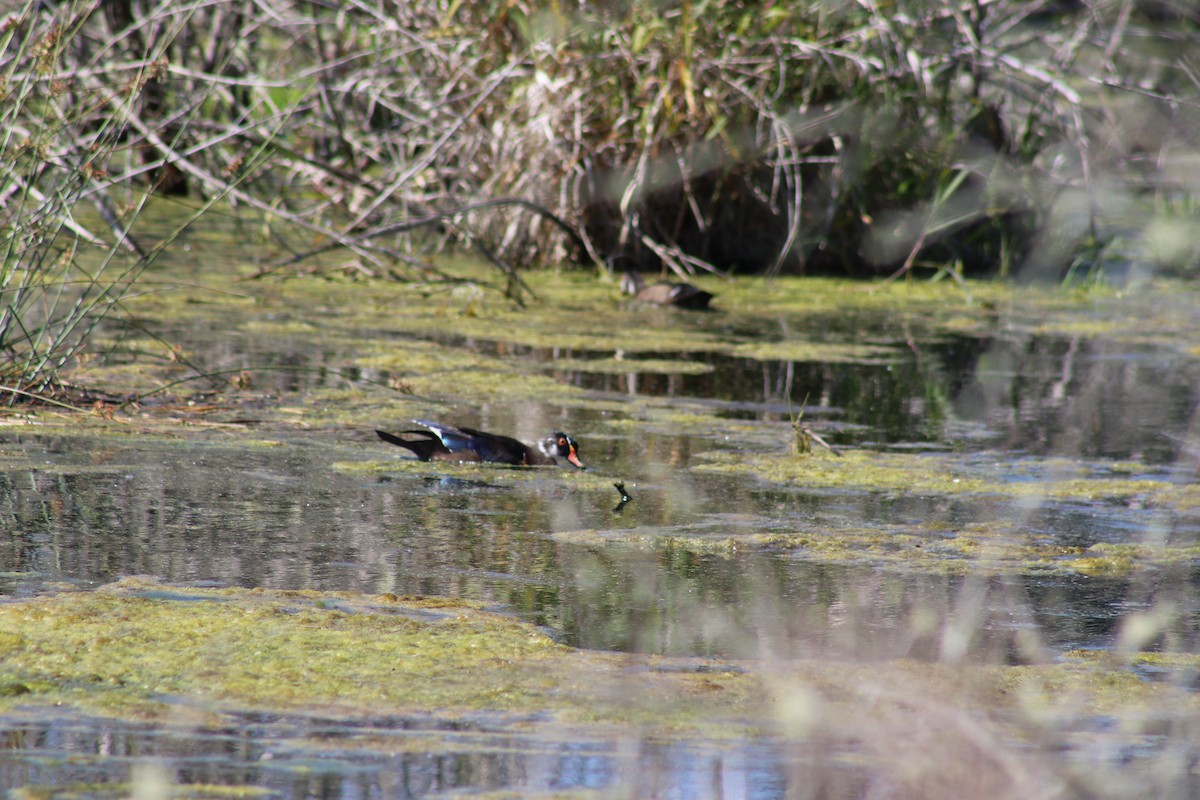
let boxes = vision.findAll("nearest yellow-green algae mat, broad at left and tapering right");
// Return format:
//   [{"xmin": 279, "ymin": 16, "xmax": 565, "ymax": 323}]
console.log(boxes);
[{"xmin": 9, "ymin": 578, "xmax": 1200, "ymax": 738}]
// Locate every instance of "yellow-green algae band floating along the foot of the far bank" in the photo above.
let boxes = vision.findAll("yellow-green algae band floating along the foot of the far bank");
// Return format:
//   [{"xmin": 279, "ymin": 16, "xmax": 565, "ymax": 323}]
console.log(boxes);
[{"xmin": 65, "ymin": 251, "xmax": 1195, "ymax": 438}]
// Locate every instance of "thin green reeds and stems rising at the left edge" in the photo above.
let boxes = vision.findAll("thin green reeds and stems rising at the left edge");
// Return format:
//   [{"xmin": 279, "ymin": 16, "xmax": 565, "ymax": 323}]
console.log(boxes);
[{"xmin": 0, "ymin": 1, "xmax": 279, "ymax": 403}]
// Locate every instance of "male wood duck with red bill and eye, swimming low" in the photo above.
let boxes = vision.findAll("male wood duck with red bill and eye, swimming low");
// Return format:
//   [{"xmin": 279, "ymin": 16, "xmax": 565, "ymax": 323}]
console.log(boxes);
[{"xmin": 376, "ymin": 420, "xmax": 584, "ymax": 469}]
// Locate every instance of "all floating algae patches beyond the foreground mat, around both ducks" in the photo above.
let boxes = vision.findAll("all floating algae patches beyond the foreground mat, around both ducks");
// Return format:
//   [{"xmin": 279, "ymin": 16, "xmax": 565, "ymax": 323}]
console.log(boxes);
[{"xmin": 41, "ymin": 253, "xmax": 1200, "ymax": 585}]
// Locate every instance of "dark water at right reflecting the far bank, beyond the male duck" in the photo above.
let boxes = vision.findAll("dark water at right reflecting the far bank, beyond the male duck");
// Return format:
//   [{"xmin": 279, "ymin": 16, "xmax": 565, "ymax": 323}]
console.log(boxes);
[{"xmin": 384, "ymin": 319, "xmax": 1200, "ymax": 465}]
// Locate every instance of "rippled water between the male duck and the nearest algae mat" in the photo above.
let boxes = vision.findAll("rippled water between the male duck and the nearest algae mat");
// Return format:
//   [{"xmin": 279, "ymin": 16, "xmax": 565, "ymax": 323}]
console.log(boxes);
[{"xmin": 0, "ymin": 438, "xmax": 1180, "ymax": 662}]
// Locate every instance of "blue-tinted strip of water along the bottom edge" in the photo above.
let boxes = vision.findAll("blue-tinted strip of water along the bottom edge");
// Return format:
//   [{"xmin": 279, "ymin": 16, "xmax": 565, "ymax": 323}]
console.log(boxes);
[{"xmin": 0, "ymin": 717, "xmax": 801, "ymax": 800}]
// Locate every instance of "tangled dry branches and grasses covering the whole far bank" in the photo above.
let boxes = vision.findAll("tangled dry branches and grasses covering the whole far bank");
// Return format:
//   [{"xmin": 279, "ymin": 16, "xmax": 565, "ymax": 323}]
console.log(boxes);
[{"xmin": 0, "ymin": 0, "xmax": 1200, "ymax": 392}]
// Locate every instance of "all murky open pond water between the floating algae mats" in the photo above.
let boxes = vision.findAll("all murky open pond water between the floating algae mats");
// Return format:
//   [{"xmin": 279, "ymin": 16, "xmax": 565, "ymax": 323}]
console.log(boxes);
[{"xmin": 0, "ymin": 266, "xmax": 1200, "ymax": 799}]
